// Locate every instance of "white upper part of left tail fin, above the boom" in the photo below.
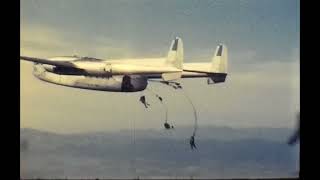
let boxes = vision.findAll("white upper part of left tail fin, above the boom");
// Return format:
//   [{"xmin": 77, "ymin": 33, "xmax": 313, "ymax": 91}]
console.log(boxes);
[{"xmin": 166, "ymin": 37, "xmax": 183, "ymax": 69}]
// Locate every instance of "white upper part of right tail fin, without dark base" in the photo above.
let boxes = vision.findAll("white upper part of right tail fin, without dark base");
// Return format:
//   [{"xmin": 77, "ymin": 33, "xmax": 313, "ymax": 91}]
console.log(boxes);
[{"xmin": 211, "ymin": 44, "xmax": 228, "ymax": 73}]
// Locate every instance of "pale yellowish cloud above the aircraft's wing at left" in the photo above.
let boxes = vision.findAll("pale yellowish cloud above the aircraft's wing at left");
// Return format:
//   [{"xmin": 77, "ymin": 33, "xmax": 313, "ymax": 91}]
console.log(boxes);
[{"xmin": 20, "ymin": 25, "xmax": 132, "ymax": 58}]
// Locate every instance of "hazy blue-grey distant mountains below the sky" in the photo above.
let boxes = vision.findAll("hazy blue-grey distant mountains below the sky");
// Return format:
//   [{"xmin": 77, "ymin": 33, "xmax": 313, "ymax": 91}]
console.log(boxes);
[{"xmin": 20, "ymin": 126, "xmax": 297, "ymax": 178}]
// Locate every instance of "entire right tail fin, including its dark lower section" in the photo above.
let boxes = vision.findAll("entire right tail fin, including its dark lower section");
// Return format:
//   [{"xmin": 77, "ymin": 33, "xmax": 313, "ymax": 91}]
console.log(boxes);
[{"xmin": 208, "ymin": 44, "xmax": 228, "ymax": 84}]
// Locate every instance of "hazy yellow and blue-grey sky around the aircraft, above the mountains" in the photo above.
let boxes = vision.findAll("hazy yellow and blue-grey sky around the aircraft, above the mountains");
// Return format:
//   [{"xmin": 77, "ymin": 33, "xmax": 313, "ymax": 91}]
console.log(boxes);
[{"xmin": 20, "ymin": 0, "xmax": 300, "ymax": 133}]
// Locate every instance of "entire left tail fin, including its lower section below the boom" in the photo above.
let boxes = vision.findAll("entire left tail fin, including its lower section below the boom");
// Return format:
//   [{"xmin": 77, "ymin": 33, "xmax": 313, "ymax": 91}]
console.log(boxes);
[{"xmin": 162, "ymin": 37, "xmax": 183, "ymax": 81}]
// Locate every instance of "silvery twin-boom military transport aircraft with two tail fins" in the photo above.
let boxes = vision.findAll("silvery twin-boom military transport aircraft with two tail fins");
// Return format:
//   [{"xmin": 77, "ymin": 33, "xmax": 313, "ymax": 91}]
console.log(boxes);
[{"xmin": 20, "ymin": 37, "xmax": 228, "ymax": 92}]
